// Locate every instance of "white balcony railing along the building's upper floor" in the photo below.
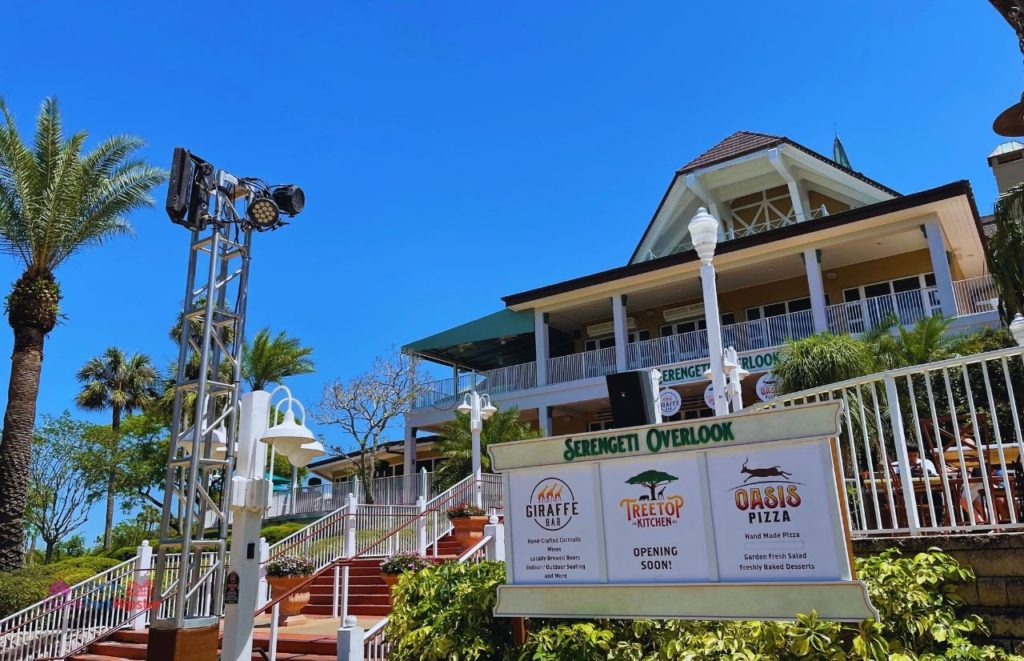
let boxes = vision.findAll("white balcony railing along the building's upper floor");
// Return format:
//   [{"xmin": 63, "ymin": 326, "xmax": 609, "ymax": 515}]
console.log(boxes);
[{"xmin": 416, "ymin": 275, "xmax": 998, "ymax": 407}]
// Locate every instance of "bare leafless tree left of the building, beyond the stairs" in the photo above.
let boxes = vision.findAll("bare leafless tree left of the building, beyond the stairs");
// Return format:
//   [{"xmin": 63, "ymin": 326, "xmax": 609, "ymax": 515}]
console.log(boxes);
[{"xmin": 313, "ymin": 351, "xmax": 423, "ymax": 502}]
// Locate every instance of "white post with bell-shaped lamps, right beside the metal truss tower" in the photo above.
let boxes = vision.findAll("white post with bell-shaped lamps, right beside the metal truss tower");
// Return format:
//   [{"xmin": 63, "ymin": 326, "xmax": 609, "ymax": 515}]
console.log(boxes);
[{"xmin": 221, "ymin": 386, "xmax": 325, "ymax": 661}]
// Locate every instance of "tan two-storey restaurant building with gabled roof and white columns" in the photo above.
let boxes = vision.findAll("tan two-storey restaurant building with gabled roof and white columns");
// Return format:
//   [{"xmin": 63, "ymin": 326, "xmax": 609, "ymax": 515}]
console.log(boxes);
[{"xmin": 394, "ymin": 131, "xmax": 999, "ymax": 474}]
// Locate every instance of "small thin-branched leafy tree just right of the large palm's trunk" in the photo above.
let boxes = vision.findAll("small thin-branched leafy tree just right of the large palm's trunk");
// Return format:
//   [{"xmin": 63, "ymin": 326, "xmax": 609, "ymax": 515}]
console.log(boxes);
[{"xmin": 26, "ymin": 411, "xmax": 96, "ymax": 563}]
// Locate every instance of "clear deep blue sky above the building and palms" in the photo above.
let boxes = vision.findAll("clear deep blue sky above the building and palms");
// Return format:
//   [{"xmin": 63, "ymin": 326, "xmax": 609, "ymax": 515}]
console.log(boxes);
[{"xmin": 0, "ymin": 0, "xmax": 1024, "ymax": 541}]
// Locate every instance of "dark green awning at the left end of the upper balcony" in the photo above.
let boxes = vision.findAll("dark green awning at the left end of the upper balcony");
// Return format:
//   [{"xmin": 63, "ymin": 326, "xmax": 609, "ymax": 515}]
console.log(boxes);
[{"xmin": 401, "ymin": 309, "xmax": 534, "ymax": 369}]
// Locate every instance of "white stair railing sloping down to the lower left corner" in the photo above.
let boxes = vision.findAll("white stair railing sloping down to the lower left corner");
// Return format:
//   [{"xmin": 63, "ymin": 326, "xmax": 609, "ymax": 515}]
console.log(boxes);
[{"xmin": 0, "ymin": 552, "xmax": 217, "ymax": 661}]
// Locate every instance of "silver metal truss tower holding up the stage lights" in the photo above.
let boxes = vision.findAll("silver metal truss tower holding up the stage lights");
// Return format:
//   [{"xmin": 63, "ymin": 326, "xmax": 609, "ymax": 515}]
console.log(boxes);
[{"xmin": 151, "ymin": 171, "xmax": 252, "ymax": 629}]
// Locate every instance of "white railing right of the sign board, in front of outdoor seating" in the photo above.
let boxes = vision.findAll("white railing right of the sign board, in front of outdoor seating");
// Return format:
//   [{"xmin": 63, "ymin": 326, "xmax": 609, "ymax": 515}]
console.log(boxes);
[{"xmin": 764, "ymin": 347, "xmax": 1024, "ymax": 536}]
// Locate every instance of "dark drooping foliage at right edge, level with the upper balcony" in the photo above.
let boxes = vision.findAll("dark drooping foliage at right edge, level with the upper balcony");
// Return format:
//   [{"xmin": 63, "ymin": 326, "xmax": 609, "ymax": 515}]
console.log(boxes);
[{"xmin": 983, "ymin": 184, "xmax": 1024, "ymax": 325}]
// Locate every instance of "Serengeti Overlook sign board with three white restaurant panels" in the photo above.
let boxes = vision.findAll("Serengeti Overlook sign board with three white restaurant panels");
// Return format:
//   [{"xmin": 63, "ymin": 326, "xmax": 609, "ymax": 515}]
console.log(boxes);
[{"xmin": 488, "ymin": 402, "xmax": 878, "ymax": 621}]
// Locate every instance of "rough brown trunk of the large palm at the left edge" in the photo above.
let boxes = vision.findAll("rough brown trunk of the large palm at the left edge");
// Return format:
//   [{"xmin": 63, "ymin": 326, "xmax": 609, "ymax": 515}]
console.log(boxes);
[{"xmin": 0, "ymin": 323, "xmax": 44, "ymax": 571}]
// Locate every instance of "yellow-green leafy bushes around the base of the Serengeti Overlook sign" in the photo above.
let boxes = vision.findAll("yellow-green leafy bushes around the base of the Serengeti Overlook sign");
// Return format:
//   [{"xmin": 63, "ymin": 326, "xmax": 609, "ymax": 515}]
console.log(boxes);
[{"xmin": 387, "ymin": 548, "xmax": 1019, "ymax": 661}]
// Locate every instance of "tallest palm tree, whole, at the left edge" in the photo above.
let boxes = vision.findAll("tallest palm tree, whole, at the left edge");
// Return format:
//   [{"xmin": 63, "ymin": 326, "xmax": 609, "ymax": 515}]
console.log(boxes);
[{"xmin": 0, "ymin": 99, "xmax": 165, "ymax": 571}]
